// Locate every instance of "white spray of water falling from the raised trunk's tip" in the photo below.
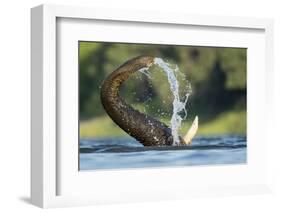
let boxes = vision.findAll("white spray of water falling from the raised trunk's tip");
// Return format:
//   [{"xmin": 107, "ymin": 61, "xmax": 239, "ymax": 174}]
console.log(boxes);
[{"xmin": 139, "ymin": 58, "xmax": 190, "ymax": 146}]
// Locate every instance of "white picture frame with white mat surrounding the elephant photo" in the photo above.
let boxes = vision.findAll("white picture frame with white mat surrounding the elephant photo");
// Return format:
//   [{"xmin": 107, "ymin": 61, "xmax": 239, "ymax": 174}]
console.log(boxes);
[{"xmin": 31, "ymin": 5, "xmax": 274, "ymax": 208}]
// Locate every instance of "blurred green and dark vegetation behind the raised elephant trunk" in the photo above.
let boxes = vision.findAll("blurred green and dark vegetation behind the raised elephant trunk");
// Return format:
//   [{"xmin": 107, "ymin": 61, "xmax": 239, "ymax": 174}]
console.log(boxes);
[{"xmin": 79, "ymin": 42, "xmax": 247, "ymax": 137}]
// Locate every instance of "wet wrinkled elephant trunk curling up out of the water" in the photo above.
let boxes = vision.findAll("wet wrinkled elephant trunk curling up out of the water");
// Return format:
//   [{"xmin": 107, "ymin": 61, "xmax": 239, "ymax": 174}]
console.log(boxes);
[{"xmin": 100, "ymin": 56, "xmax": 184, "ymax": 146}]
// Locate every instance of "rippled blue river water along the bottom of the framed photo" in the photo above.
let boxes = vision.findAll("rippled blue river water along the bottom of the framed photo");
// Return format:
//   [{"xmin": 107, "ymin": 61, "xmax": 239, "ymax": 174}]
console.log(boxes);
[{"xmin": 80, "ymin": 135, "xmax": 247, "ymax": 170}]
